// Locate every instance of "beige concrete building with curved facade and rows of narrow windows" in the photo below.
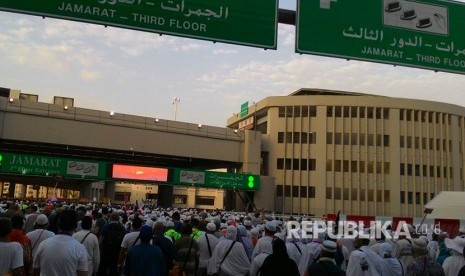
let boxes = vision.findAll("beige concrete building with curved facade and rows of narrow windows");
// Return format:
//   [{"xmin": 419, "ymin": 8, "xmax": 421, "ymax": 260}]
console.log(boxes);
[{"xmin": 227, "ymin": 89, "xmax": 465, "ymax": 217}]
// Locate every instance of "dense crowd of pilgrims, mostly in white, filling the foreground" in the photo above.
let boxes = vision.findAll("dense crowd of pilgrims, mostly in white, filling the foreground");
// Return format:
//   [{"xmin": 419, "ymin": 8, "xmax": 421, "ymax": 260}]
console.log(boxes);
[{"xmin": 0, "ymin": 202, "xmax": 465, "ymax": 276}]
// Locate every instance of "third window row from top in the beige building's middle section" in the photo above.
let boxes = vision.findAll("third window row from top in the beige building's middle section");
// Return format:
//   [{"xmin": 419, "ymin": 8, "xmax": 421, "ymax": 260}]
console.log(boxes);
[{"xmin": 326, "ymin": 159, "xmax": 391, "ymax": 174}]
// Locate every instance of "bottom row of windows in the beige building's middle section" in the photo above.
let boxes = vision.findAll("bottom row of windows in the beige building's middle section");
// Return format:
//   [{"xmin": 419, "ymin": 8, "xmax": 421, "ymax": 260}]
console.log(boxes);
[{"xmin": 326, "ymin": 187, "xmax": 391, "ymax": 202}]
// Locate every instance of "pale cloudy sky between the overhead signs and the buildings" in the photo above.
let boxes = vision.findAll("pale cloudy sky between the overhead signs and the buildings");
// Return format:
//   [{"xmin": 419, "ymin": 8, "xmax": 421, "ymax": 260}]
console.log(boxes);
[{"xmin": 0, "ymin": 0, "xmax": 465, "ymax": 126}]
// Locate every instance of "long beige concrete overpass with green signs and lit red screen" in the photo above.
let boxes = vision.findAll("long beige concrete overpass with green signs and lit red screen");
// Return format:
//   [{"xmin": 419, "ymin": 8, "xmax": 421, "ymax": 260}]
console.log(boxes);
[{"xmin": 0, "ymin": 93, "xmax": 273, "ymax": 208}]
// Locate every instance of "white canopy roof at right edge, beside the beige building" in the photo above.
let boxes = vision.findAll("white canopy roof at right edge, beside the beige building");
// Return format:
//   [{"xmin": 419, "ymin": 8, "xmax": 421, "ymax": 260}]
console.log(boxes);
[{"xmin": 425, "ymin": 191, "xmax": 465, "ymax": 220}]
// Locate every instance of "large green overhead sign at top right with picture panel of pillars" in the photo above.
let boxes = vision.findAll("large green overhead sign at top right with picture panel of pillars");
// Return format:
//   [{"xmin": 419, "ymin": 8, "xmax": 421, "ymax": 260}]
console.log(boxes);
[{"xmin": 296, "ymin": 0, "xmax": 465, "ymax": 74}]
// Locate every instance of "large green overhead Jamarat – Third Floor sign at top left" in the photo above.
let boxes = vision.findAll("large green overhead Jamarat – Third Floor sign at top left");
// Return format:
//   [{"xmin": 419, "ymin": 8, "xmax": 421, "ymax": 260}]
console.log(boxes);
[{"xmin": 0, "ymin": 0, "xmax": 279, "ymax": 49}]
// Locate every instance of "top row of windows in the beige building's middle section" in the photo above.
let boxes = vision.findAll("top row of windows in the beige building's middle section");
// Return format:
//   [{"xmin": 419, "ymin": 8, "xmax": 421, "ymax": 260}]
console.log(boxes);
[{"xmin": 326, "ymin": 106, "xmax": 389, "ymax": 119}]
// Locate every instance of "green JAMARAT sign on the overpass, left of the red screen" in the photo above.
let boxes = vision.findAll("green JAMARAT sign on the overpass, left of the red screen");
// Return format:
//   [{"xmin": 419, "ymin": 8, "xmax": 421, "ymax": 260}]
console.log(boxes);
[{"xmin": 0, "ymin": 153, "xmax": 107, "ymax": 179}]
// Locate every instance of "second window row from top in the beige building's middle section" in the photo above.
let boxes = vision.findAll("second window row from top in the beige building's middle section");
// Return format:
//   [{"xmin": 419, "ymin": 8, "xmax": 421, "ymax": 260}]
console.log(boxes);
[{"xmin": 326, "ymin": 132, "xmax": 389, "ymax": 147}]
